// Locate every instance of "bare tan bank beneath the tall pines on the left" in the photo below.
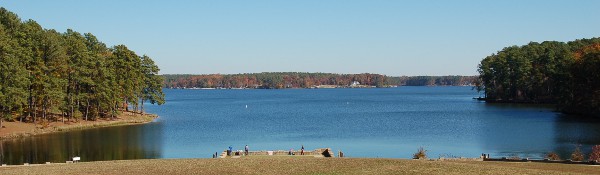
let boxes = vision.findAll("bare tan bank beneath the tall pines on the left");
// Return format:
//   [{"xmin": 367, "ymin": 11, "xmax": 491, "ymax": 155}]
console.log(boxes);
[{"xmin": 0, "ymin": 112, "xmax": 158, "ymax": 140}]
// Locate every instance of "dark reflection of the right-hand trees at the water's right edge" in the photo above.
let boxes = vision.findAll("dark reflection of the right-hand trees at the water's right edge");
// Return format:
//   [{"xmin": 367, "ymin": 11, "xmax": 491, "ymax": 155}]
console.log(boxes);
[{"xmin": 554, "ymin": 115, "xmax": 600, "ymax": 159}]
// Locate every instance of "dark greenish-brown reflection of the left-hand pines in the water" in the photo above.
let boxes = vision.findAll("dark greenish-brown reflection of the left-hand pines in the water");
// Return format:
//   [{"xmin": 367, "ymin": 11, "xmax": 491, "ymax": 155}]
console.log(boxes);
[{"xmin": 0, "ymin": 123, "xmax": 163, "ymax": 164}]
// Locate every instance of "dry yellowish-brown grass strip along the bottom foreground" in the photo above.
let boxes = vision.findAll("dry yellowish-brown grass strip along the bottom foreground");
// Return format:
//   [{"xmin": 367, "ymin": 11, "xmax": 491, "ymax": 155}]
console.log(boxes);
[{"xmin": 0, "ymin": 156, "xmax": 600, "ymax": 175}]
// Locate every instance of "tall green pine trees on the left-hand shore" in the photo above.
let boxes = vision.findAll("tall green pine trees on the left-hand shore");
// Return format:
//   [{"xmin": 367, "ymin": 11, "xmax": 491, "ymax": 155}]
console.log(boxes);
[{"xmin": 0, "ymin": 8, "xmax": 164, "ymax": 125}]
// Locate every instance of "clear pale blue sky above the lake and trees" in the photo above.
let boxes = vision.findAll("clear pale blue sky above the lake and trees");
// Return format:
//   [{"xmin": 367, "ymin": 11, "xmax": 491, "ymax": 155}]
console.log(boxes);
[{"xmin": 0, "ymin": 0, "xmax": 600, "ymax": 76}]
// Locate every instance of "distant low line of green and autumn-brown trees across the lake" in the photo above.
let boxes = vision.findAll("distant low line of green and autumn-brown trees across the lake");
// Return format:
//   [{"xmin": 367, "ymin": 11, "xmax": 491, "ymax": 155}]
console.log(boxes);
[{"xmin": 162, "ymin": 72, "xmax": 477, "ymax": 89}]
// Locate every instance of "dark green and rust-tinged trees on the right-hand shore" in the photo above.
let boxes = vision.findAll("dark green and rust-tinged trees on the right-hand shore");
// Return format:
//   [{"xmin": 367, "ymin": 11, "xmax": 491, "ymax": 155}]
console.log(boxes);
[{"xmin": 477, "ymin": 38, "xmax": 600, "ymax": 117}]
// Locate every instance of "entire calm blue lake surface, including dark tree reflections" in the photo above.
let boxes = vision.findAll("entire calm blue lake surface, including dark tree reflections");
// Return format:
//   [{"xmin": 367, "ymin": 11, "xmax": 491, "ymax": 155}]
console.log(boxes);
[{"xmin": 1, "ymin": 87, "xmax": 600, "ymax": 164}]
